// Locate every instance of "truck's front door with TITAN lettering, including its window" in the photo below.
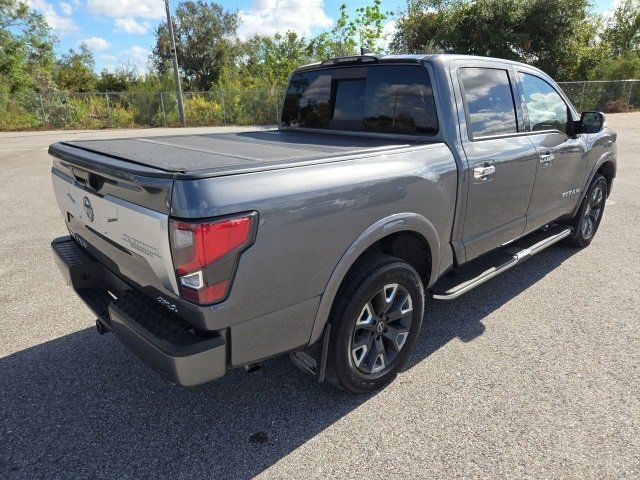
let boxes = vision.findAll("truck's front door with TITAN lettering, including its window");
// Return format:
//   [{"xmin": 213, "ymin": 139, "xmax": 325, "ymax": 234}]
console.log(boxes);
[{"xmin": 518, "ymin": 69, "xmax": 587, "ymax": 232}]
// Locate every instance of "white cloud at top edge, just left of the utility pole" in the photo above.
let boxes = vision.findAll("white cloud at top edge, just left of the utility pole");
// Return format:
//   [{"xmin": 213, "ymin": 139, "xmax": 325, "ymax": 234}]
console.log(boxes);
[{"xmin": 87, "ymin": 0, "xmax": 165, "ymax": 35}]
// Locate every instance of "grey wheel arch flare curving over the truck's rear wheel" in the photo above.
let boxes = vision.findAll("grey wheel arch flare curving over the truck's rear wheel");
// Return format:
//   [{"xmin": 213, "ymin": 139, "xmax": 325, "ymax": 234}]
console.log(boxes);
[{"xmin": 309, "ymin": 212, "xmax": 441, "ymax": 345}]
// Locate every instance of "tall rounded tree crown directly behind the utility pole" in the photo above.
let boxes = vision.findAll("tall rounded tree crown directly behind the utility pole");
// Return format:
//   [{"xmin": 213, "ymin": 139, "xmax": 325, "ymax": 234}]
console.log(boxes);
[{"xmin": 153, "ymin": 0, "xmax": 240, "ymax": 90}]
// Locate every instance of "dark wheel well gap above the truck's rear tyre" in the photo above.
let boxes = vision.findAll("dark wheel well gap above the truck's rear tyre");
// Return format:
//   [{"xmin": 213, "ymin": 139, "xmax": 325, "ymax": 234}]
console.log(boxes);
[{"xmin": 351, "ymin": 231, "xmax": 431, "ymax": 285}]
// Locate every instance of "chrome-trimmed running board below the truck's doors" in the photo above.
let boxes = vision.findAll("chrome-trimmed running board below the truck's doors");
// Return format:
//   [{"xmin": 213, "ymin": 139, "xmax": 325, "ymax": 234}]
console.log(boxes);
[{"xmin": 431, "ymin": 227, "xmax": 572, "ymax": 300}]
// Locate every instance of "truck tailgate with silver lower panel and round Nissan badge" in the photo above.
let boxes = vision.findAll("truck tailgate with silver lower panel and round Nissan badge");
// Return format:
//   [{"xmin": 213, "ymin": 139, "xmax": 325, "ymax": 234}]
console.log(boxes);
[{"xmin": 52, "ymin": 150, "xmax": 178, "ymax": 294}]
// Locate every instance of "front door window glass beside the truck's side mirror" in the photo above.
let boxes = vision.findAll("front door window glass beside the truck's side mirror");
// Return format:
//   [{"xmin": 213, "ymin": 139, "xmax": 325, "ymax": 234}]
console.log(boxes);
[{"xmin": 520, "ymin": 73, "xmax": 567, "ymax": 132}]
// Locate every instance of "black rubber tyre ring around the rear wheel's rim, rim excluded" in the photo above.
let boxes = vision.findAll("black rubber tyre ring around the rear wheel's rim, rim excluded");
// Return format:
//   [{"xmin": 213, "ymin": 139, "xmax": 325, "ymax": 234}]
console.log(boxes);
[{"xmin": 334, "ymin": 262, "xmax": 424, "ymax": 391}]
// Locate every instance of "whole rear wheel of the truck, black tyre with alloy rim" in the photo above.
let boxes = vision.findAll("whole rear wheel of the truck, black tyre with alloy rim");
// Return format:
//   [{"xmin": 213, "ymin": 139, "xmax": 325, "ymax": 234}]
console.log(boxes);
[{"xmin": 326, "ymin": 254, "xmax": 424, "ymax": 393}]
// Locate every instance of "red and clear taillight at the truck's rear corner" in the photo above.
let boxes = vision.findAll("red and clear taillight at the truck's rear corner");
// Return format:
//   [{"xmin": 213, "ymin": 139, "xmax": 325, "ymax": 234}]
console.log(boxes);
[{"xmin": 171, "ymin": 212, "xmax": 257, "ymax": 305}]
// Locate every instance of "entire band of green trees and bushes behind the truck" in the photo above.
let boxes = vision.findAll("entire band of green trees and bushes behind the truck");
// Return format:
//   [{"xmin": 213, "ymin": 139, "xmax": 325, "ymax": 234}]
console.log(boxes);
[{"xmin": 0, "ymin": 0, "xmax": 640, "ymax": 130}]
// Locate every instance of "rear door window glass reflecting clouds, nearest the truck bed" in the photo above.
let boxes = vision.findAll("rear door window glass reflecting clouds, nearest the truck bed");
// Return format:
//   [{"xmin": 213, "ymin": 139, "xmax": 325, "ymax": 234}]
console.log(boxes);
[{"xmin": 459, "ymin": 67, "xmax": 518, "ymax": 139}]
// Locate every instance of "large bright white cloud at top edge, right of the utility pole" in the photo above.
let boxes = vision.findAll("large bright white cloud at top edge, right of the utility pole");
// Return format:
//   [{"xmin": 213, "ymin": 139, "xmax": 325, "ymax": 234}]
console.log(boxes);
[{"xmin": 238, "ymin": 0, "xmax": 333, "ymax": 38}]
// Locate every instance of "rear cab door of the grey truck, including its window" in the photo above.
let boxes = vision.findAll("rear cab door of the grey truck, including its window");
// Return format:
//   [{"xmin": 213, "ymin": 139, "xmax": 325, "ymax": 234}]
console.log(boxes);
[{"xmin": 452, "ymin": 61, "xmax": 538, "ymax": 260}]
